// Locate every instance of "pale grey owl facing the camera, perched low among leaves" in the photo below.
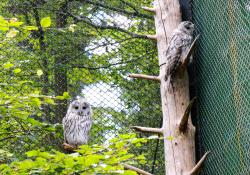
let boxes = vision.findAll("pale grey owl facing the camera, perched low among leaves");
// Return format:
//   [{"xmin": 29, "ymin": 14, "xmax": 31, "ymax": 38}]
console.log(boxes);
[{"xmin": 63, "ymin": 98, "xmax": 92, "ymax": 147}]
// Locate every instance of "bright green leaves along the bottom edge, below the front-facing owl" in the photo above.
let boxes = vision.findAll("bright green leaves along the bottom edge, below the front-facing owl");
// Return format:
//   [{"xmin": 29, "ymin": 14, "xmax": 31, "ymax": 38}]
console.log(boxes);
[{"xmin": 0, "ymin": 134, "xmax": 146, "ymax": 175}]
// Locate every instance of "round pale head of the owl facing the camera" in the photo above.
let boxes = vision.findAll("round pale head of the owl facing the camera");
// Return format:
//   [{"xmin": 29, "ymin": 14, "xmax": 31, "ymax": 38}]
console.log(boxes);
[{"xmin": 67, "ymin": 98, "xmax": 92, "ymax": 116}]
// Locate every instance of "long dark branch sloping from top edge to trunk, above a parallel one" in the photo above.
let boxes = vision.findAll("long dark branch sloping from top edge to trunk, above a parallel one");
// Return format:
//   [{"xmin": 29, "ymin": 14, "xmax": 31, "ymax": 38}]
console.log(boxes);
[{"xmin": 79, "ymin": 0, "xmax": 153, "ymax": 19}]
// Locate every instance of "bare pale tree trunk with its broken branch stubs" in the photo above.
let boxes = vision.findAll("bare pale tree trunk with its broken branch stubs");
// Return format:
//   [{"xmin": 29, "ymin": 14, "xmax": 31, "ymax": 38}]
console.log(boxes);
[{"xmin": 130, "ymin": 0, "xmax": 209, "ymax": 175}]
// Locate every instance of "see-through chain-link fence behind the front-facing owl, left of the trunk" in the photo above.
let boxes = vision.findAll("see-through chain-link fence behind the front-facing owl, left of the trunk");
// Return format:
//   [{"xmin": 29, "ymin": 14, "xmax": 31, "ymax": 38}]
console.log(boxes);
[{"xmin": 0, "ymin": 0, "xmax": 164, "ymax": 174}]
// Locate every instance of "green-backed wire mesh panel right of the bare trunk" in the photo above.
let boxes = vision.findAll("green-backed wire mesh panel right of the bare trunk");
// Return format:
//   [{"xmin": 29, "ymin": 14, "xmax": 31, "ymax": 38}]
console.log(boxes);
[{"xmin": 192, "ymin": 0, "xmax": 250, "ymax": 175}]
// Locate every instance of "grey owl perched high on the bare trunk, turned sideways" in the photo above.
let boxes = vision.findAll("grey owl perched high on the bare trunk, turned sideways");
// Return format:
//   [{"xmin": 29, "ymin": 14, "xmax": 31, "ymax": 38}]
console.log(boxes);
[{"xmin": 165, "ymin": 21, "xmax": 194, "ymax": 80}]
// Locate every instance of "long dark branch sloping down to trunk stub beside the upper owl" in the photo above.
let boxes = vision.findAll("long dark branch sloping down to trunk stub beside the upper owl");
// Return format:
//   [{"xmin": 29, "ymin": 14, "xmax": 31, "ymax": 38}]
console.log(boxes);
[{"xmin": 64, "ymin": 12, "xmax": 152, "ymax": 39}]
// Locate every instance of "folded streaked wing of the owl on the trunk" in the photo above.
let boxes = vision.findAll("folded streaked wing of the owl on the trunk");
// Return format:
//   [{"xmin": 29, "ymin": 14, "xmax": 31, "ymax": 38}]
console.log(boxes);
[{"xmin": 165, "ymin": 31, "xmax": 190, "ymax": 79}]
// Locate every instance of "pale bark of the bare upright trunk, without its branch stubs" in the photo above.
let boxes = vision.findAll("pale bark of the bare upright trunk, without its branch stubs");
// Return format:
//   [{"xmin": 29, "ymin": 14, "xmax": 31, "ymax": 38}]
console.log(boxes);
[{"xmin": 155, "ymin": 0, "xmax": 195, "ymax": 175}]
